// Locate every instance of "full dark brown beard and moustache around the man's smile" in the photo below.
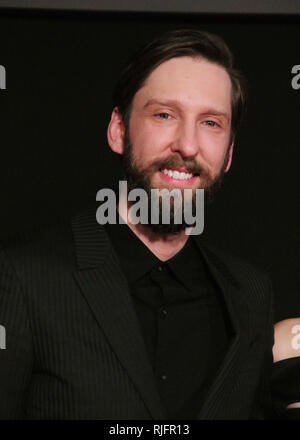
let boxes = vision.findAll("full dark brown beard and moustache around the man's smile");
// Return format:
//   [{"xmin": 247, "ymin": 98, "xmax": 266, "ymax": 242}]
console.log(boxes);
[{"xmin": 122, "ymin": 136, "xmax": 229, "ymax": 236}]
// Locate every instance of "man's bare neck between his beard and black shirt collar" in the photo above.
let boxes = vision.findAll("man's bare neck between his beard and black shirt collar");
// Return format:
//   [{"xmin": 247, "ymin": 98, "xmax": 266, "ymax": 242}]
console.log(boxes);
[{"xmin": 118, "ymin": 198, "xmax": 189, "ymax": 261}]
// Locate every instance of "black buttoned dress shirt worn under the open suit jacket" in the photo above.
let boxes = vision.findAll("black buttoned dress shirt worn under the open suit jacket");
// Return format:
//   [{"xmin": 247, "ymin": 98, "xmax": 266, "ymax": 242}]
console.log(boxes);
[{"xmin": 106, "ymin": 224, "xmax": 230, "ymax": 419}]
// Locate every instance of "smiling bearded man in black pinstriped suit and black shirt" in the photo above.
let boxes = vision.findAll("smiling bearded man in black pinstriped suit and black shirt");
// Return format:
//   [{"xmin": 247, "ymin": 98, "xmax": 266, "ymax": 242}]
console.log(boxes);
[{"xmin": 0, "ymin": 30, "xmax": 273, "ymax": 419}]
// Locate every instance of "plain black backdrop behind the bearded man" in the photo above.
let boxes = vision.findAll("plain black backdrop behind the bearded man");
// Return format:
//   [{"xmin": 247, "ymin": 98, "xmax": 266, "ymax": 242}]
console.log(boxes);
[{"xmin": 0, "ymin": 11, "xmax": 300, "ymax": 321}]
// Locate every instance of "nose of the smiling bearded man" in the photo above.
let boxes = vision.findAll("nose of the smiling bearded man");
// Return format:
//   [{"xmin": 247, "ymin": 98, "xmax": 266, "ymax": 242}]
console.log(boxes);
[{"xmin": 171, "ymin": 120, "xmax": 199, "ymax": 159}]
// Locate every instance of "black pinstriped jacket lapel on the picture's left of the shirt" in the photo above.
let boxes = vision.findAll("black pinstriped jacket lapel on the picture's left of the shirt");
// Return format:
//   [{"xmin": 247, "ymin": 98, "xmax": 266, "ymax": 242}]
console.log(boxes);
[{"xmin": 72, "ymin": 210, "xmax": 164, "ymax": 419}]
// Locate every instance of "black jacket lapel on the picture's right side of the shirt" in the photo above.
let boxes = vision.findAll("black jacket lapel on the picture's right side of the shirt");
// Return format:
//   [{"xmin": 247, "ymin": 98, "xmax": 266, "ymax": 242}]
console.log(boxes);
[{"xmin": 196, "ymin": 240, "xmax": 249, "ymax": 419}]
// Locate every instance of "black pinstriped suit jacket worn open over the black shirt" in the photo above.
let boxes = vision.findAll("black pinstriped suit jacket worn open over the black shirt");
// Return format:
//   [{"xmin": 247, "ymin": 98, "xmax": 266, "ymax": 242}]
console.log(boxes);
[{"xmin": 0, "ymin": 210, "xmax": 273, "ymax": 420}]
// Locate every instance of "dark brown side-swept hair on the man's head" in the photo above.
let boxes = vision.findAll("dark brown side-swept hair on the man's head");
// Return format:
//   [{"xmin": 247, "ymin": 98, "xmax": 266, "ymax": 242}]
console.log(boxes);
[{"xmin": 113, "ymin": 29, "xmax": 246, "ymax": 140}]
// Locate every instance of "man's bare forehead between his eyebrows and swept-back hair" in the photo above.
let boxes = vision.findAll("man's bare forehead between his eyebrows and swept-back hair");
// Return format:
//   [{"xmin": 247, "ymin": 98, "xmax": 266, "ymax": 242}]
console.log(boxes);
[{"xmin": 133, "ymin": 57, "xmax": 231, "ymax": 113}]
